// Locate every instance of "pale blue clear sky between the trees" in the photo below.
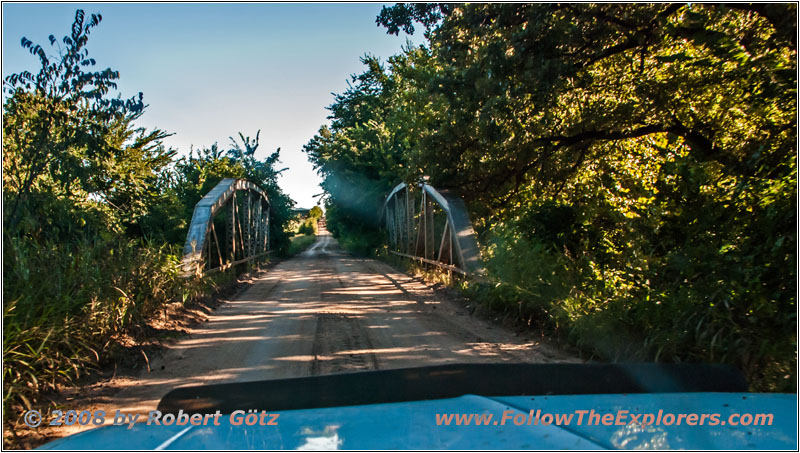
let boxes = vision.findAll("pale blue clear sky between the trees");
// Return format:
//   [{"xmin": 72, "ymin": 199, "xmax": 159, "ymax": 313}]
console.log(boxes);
[{"xmin": 2, "ymin": 3, "xmax": 418, "ymax": 208}]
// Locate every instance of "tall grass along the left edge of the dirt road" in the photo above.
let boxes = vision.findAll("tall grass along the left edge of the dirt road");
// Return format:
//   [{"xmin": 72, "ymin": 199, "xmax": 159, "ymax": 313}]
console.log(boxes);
[{"xmin": 3, "ymin": 236, "xmax": 205, "ymax": 421}]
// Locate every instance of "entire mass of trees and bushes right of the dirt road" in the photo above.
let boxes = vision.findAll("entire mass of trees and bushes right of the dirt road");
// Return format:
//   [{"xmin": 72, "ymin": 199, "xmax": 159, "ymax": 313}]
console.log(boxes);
[{"xmin": 305, "ymin": 4, "xmax": 797, "ymax": 391}]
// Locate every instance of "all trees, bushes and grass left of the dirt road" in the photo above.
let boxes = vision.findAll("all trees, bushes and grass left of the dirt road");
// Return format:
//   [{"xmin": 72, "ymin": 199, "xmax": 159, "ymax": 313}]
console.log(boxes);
[{"xmin": 3, "ymin": 10, "xmax": 293, "ymax": 426}]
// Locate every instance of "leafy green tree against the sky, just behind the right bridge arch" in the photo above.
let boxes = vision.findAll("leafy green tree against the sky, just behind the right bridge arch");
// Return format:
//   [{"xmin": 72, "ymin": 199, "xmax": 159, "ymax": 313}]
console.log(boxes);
[{"xmin": 303, "ymin": 56, "xmax": 405, "ymax": 254}]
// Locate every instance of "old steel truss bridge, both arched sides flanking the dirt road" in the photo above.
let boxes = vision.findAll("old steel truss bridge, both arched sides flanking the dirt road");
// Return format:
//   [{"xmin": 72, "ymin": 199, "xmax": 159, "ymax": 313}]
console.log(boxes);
[{"xmin": 182, "ymin": 178, "xmax": 484, "ymax": 276}]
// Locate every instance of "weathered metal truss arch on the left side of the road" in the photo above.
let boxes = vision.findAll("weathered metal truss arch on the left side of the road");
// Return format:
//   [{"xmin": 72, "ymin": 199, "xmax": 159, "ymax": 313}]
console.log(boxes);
[{"xmin": 181, "ymin": 178, "xmax": 270, "ymax": 276}]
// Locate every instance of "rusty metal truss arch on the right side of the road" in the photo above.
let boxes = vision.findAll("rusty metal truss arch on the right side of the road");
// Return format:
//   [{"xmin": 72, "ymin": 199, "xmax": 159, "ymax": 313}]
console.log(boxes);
[{"xmin": 380, "ymin": 183, "xmax": 485, "ymax": 276}]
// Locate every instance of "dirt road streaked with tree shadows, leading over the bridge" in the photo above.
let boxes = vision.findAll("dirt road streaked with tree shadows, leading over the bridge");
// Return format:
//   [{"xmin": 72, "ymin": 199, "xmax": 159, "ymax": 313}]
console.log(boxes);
[{"xmin": 98, "ymin": 231, "xmax": 575, "ymax": 420}]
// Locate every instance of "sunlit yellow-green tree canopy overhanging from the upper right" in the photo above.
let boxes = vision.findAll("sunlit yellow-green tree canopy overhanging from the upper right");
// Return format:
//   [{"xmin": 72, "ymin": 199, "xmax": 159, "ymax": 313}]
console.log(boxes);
[{"xmin": 382, "ymin": 4, "xmax": 795, "ymax": 210}]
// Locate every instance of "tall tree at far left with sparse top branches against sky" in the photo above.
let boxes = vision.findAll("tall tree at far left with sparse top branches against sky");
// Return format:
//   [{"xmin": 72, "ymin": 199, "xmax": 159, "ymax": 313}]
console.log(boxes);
[{"xmin": 3, "ymin": 10, "xmax": 174, "ymax": 237}]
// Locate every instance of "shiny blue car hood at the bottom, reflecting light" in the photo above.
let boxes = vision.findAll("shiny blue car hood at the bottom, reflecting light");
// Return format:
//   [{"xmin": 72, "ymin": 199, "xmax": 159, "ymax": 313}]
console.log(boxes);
[{"xmin": 40, "ymin": 392, "xmax": 797, "ymax": 450}]
